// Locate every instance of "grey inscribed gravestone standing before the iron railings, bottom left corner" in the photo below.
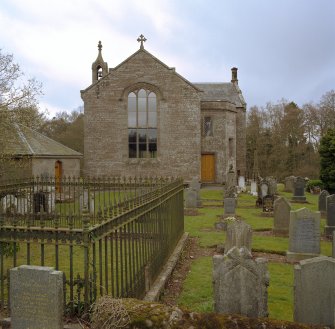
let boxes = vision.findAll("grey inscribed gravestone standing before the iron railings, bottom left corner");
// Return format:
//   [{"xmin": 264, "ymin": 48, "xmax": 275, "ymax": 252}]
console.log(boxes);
[{"xmin": 10, "ymin": 265, "xmax": 64, "ymax": 329}]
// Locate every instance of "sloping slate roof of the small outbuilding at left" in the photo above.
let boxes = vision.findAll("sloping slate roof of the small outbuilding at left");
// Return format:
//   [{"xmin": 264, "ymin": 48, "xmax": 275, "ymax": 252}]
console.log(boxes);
[{"xmin": 3, "ymin": 123, "xmax": 82, "ymax": 157}]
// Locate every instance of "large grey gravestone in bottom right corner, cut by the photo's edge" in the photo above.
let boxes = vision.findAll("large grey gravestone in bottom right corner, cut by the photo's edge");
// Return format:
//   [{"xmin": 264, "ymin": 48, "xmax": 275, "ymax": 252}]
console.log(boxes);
[{"xmin": 294, "ymin": 256, "xmax": 335, "ymax": 328}]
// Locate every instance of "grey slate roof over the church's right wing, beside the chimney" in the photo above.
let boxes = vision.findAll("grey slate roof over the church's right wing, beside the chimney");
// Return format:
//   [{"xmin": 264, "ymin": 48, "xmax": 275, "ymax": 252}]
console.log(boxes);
[{"xmin": 193, "ymin": 82, "xmax": 245, "ymax": 107}]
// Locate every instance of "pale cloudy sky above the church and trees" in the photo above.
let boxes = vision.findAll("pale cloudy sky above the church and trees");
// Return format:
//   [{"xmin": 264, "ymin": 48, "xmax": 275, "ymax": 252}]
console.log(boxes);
[{"xmin": 0, "ymin": 0, "xmax": 335, "ymax": 114}]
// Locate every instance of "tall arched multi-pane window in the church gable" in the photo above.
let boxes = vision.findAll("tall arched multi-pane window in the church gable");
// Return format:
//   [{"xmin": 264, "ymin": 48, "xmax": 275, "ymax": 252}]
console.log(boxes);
[{"xmin": 128, "ymin": 89, "xmax": 157, "ymax": 158}]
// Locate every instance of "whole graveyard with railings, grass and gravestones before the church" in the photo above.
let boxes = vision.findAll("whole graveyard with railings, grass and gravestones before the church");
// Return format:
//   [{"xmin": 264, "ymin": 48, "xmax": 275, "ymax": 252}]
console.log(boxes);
[{"xmin": 0, "ymin": 179, "xmax": 335, "ymax": 328}]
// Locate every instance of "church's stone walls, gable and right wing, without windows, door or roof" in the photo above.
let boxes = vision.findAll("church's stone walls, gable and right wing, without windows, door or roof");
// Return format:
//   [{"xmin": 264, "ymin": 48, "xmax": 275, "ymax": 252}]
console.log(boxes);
[{"xmin": 81, "ymin": 39, "xmax": 245, "ymax": 182}]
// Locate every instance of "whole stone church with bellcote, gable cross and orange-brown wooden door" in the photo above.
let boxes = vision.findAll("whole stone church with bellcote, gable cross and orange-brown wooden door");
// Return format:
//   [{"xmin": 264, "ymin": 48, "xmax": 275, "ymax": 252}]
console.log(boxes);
[{"xmin": 81, "ymin": 35, "xmax": 246, "ymax": 183}]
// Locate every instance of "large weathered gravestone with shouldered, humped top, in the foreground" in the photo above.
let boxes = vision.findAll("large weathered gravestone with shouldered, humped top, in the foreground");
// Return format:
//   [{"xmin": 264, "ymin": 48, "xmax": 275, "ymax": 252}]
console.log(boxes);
[{"xmin": 213, "ymin": 247, "xmax": 269, "ymax": 318}]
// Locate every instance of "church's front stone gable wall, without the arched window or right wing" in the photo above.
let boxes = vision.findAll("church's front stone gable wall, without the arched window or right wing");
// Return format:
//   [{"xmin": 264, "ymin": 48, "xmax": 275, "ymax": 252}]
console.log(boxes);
[{"xmin": 82, "ymin": 51, "xmax": 201, "ymax": 180}]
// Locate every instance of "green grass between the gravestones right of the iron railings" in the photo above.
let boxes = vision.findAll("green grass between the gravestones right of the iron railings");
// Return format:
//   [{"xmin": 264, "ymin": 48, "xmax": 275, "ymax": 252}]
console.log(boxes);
[{"xmin": 177, "ymin": 184, "xmax": 332, "ymax": 321}]
